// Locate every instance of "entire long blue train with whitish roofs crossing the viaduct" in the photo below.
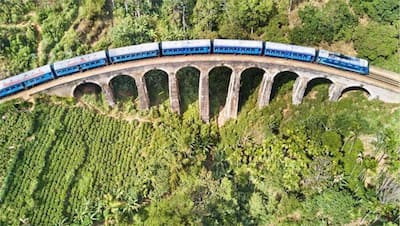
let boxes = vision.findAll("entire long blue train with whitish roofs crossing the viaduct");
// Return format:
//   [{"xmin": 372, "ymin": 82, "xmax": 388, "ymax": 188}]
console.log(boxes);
[{"xmin": 0, "ymin": 39, "xmax": 369, "ymax": 98}]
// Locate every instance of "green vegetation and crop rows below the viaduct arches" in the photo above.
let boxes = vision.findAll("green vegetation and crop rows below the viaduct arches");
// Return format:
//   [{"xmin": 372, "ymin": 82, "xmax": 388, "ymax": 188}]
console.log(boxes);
[{"xmin": 0, "ymin": 74, "xmax": 400, "ymax": 225}]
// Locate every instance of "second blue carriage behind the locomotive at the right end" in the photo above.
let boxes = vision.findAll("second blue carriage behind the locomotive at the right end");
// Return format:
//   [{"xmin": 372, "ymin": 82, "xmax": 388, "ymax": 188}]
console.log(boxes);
[{"xmin": 213, "ymin": 39, "xmax": 263, "ymax": 55}]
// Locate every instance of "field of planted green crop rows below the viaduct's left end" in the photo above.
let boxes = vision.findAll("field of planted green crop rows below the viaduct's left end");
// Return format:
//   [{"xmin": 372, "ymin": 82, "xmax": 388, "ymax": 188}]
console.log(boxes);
[{"xmin": 0, "ymin": 106, "xmax": 162, "ymax": 225}]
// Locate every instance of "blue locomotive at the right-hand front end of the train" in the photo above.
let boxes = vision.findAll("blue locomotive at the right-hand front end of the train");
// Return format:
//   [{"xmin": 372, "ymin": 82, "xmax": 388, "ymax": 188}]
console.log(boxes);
[{"xmin": 316, "ymin": 49, "xmax": 369, "ymax": 75}]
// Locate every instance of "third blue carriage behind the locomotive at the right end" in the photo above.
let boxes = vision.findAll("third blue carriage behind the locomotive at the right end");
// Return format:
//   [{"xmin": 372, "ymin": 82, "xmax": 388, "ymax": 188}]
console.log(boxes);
[{"xmin": 161, "ymin": 39, "xmax": 211, "ymax": 56}]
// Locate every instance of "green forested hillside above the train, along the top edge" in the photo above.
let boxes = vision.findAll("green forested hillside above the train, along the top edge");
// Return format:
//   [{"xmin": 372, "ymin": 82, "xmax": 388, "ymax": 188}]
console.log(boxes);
[{"xmin": 0, "ymin": 0, "xmax": 400, "ymax": 77}]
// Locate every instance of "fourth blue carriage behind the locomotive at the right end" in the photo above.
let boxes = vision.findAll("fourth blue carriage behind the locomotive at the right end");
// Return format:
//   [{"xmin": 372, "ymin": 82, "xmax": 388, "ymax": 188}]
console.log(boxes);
[{"xmin": 108, "ymin": 42, "xmax": 160, "ymax": 63}]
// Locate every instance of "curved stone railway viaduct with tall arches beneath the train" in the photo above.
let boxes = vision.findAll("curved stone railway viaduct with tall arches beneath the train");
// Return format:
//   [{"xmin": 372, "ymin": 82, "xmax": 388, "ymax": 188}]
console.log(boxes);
[{"xmin": 2, "ymin": 54, "xmax": 400, "ymax": 124}]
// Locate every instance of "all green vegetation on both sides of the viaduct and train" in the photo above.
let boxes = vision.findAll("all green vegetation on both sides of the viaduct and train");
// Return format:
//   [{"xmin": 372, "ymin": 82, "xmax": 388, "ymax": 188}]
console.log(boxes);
[{"xmin": 0, "ymin": 0, "xmax": 400, "ymax": 225}]
